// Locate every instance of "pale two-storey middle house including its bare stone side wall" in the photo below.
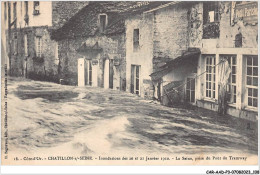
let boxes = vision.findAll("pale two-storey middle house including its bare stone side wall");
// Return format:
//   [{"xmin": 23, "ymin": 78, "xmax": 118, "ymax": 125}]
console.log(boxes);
[{"xmin": 126, "ymin": 2, "xmax": 188, "ymax": 99}]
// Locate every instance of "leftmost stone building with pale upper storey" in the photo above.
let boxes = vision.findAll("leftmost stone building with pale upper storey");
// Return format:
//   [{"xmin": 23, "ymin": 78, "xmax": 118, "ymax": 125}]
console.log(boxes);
[{"xmin": 2, "ymin": 1, "xmax": 88, "ymax": 81}]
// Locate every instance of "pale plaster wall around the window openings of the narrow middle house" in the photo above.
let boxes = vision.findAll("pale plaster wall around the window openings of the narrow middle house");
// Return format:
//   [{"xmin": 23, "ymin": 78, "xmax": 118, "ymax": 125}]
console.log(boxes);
[{"xmin": 125, "ymin": 14, "xmax": 153, "ymax": 98}]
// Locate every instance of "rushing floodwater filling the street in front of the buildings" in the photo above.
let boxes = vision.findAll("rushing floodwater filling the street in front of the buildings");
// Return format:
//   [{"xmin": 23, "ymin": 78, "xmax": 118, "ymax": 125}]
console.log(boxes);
[{"xmin": 4, "ymin": 78, "xmax": 258, "ymax": 155}]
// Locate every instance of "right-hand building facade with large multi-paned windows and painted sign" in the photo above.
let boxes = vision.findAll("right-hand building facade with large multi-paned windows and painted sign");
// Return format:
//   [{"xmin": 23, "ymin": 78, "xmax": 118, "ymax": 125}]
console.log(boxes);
[{"xmin": 194, "ymin": 2, "xmax": 258, "ymax": 120}]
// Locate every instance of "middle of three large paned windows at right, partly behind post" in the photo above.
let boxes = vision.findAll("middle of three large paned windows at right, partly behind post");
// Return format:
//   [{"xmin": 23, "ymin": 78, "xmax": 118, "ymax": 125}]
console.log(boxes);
[{"xmin": 220, "ymin": 55, "xmax": 237, "ymax": 103}]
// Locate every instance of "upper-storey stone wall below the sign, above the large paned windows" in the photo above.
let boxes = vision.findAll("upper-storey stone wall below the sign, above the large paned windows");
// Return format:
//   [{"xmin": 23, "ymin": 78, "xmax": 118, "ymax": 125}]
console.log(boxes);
[{"xmin": 189, "ymin": 2, "xmax": 258, "ymax": 48}]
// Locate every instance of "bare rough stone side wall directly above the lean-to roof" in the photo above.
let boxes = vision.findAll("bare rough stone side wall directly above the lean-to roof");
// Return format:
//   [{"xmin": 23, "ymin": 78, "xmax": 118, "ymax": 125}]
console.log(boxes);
[{"xmin": 153, "ymin": 4, "xmax": 188, "ymax": 59}]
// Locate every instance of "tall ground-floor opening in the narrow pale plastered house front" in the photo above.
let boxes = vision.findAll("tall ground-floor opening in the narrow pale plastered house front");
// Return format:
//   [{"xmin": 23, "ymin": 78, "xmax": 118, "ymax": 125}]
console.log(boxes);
[{"xmin": 131, "ymin": 65, "xmax": 141, "ymax": 95}]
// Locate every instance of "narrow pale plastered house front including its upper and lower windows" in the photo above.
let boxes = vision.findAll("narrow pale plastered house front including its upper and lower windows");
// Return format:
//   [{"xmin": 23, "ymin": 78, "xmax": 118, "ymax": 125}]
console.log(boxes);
[{"xmin": 125, "ymin": 14, "xmax": 153, "ymax": 97}]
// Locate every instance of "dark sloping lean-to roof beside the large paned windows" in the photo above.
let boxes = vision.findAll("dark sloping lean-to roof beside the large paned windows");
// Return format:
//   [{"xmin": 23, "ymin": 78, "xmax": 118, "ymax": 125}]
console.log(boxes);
[{"xmin": 150, "ymin": 48, "xmax": 201, "ymax": 81}]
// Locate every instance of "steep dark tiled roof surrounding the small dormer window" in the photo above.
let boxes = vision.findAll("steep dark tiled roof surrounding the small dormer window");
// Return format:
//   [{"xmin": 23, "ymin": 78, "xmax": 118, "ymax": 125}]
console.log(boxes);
[{"xmin": 52, "ymin": 1, "xmax": 169, "ymax": 40}]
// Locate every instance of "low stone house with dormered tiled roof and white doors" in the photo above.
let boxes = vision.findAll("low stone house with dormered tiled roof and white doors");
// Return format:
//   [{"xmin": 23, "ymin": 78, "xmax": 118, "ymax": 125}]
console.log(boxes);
[{"xmin": 52, "ymin": 1, "xmax": 165, "ymax": 91}]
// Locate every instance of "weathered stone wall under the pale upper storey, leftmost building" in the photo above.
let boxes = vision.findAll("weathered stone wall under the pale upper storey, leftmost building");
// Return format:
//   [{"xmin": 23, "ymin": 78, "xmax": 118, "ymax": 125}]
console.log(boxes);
[{"xmin": 7, "ymin": 27, "xmax": 58, "ymax": 82}]
